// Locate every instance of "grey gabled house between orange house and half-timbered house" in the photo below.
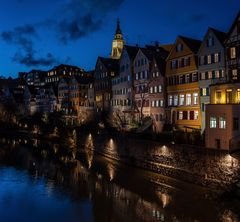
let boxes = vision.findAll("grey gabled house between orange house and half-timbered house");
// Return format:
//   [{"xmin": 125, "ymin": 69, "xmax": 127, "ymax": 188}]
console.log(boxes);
[{"xmin": 198, "ymin": 28, "xmax": 226, "ymax": 132}]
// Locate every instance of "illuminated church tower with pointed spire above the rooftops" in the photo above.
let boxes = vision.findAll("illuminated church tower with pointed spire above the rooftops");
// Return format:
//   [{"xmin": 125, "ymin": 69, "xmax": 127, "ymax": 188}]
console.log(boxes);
[{"xmin": 111, "ymin": 19, "xmax": 124, "ymax": 59}]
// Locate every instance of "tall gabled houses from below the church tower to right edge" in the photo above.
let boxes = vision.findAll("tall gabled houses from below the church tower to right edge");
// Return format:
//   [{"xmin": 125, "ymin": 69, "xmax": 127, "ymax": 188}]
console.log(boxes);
[{"xmin": 94, "ymin": 13, "xmax": 240, "ymax": 152}]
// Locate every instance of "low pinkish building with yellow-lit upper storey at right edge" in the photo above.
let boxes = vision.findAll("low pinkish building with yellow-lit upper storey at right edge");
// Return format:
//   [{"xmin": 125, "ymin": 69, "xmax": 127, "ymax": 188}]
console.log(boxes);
[{"xmin": 205, "ymin": 83, "xmax": 240, "ymax": 151}]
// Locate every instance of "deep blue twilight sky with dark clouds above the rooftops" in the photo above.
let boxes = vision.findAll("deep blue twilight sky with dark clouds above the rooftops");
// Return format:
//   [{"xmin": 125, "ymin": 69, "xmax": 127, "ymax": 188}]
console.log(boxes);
[{"xmin": 0, "ymin": 0, "xmax": 240, "ymax": 77}]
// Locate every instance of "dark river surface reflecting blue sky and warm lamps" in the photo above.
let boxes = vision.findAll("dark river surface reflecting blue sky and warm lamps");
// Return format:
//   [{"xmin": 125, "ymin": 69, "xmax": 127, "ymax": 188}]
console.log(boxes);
[{"xmin": 0, "ymin": 136, "xmax": 240, "ymax": 222}]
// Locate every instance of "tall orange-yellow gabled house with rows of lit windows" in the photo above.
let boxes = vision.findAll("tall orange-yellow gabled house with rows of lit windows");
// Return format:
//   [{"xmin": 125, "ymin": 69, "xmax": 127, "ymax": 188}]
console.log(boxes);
[{"xmin": 166, "ymin": 36, "xmax": 201, "ymax": 131}]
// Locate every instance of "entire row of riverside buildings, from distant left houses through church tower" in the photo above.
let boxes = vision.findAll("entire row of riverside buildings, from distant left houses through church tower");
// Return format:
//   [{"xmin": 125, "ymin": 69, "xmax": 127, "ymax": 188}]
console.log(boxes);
[{"xmin": 1, "ymin": 13, "xmax": 240, "ymax": 149}]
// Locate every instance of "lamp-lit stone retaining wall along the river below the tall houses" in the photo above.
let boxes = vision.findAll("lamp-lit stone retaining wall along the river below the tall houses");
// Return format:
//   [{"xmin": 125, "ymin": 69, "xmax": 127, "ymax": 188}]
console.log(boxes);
[{"xmin": 82, "ymin": 132, "xmax": 240, "ymax": 187}]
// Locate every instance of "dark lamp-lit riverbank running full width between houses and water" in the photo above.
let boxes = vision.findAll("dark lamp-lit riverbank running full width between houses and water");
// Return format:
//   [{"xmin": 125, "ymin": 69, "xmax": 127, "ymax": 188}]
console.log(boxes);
[{"xmin": 0, "ymin": 126, "xmax": 240, "ymax": 192}]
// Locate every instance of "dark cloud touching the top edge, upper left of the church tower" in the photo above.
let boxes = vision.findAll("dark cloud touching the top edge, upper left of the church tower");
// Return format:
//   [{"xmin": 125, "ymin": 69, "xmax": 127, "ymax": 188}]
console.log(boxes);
[{"xmin": 54, "ymin": 0, "xmax": 124, "ymax": 43}]
